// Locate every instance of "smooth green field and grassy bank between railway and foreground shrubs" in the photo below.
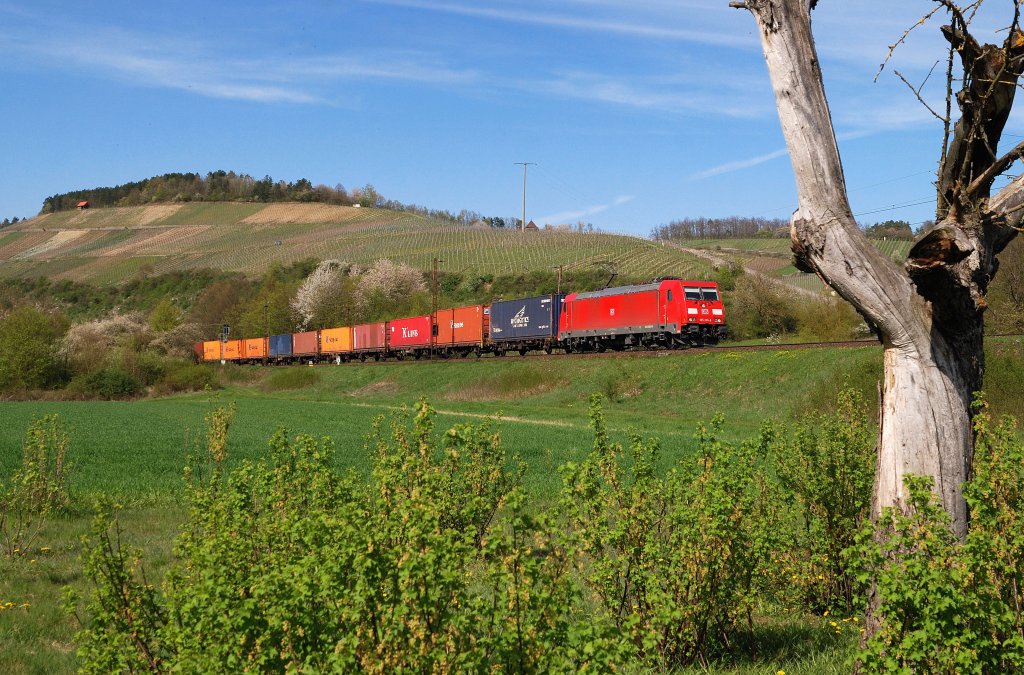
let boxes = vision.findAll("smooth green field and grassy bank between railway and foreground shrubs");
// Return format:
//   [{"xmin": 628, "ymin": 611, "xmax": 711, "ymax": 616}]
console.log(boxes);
[{"xmin": 0, "ymin": 347, "xmax": 881, "ymax": 499}]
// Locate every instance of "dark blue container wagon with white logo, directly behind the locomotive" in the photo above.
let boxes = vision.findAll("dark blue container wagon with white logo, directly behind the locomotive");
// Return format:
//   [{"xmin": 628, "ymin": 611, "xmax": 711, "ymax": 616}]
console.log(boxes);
[{"xmin": 489, "ymin": 294, "xmax": 565, "ymax": 356}]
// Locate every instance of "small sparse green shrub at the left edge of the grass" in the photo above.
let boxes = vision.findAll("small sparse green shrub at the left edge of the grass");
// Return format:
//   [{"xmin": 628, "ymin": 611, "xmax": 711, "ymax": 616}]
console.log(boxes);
[{"xmin": 0, "ymin": 415, "xmax": 71, "ymax": 557}]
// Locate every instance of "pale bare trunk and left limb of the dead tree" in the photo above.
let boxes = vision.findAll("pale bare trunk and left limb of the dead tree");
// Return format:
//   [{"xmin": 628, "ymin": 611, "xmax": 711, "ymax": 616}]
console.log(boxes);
[{"xmin": 734, "ymin": 0, "xmax": 985, "ymax": 538}]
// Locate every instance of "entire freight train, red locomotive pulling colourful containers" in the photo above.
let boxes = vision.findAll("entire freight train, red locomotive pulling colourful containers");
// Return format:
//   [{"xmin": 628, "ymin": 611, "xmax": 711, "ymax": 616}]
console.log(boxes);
[{"xmin": 195, "ymin": 278, "xmax": 726, "ymax": 364}]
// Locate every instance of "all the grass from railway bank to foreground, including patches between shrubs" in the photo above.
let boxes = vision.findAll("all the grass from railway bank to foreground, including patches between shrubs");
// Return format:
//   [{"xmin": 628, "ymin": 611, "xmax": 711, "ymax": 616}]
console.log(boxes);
[{"xmin": 0, "ymin": 341, "xmax": 1024, "ymax": 675}]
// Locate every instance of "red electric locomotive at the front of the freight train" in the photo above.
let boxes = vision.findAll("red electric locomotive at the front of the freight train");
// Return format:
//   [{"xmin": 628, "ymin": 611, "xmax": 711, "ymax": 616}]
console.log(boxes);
[{"xmin": 558, "ymin": 279, "xmax": 726, "ymax": 351}]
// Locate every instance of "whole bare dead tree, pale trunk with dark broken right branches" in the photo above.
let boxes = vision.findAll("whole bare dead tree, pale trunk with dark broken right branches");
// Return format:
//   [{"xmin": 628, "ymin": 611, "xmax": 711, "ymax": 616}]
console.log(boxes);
[{"xmin": 730, "ymin": 0, "xmax": 1024, "ymax": 553}]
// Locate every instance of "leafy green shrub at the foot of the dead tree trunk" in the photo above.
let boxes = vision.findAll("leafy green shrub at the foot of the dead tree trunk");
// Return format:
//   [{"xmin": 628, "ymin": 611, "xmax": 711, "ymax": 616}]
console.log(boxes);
[{"xmin": 852, "ymin": 399, "xmax": 1024, "ymax": 673}]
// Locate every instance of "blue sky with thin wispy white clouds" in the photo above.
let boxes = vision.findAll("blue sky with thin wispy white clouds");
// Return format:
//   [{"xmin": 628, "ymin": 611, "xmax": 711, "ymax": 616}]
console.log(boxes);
[{"xmin": 0, "ymin": 0, "xmax": 1024, "ymax": 235}]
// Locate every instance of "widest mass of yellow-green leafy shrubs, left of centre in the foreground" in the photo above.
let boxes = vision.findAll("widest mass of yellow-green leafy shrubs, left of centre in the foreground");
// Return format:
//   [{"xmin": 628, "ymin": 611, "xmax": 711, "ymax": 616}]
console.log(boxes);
[{"xmin": 71, "ymin": 403, "xmax": 624, "ymax": 673}]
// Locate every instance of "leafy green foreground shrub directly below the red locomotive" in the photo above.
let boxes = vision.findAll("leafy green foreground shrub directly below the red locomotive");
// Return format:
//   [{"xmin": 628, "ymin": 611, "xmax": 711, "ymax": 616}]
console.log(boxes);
[{"xmin": 560, "ymin": 396, "xmax": 777, "ymax": 668}]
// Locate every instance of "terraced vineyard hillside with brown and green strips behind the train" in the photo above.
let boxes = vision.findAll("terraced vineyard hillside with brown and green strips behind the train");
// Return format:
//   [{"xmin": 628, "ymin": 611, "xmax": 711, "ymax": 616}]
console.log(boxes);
[{"xmin": 0, "ymin": 203, "xmax": 712, "ymax": 285}]
